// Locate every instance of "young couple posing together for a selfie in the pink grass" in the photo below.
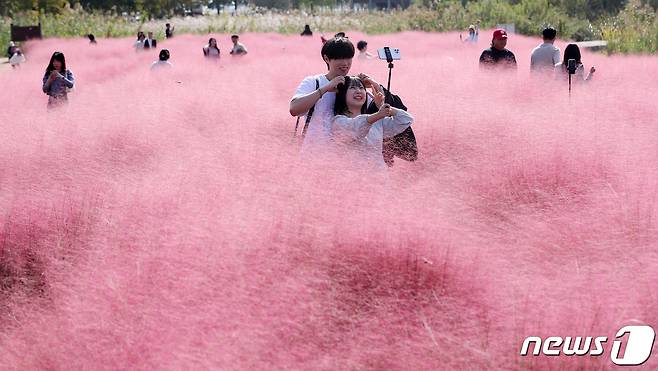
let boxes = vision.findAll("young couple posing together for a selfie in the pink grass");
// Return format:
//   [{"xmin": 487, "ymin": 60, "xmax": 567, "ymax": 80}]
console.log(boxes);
[{"xmin": 290, "ymin": 37, "xmax": 418, "ymax": 168}]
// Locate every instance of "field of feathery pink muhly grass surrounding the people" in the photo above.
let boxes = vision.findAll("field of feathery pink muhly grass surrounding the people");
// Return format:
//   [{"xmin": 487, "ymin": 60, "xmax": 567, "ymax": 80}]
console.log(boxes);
[{"xmin": 0, "ymin": 31, "xmax": 658, "ymax": 370}]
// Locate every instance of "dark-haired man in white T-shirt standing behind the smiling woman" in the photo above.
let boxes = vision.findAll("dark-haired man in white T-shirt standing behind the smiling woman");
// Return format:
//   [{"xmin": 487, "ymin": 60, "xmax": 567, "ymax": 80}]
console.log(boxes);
[{"xmin": 290, "ymin": 37, "xmax": 354, "ymax": 150}]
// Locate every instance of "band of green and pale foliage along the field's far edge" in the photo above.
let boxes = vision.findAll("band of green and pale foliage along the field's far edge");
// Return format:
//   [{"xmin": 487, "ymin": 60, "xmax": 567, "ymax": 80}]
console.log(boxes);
[{"xmin": 0, "ymin": 0, "xmax": 658, "ymax": 53}]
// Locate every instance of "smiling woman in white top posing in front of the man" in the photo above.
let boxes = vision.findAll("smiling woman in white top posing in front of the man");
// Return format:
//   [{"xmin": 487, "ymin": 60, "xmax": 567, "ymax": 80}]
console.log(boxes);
[{"xmin": 332, "ymin": 74, "xmax": 414, "ymax": 169}]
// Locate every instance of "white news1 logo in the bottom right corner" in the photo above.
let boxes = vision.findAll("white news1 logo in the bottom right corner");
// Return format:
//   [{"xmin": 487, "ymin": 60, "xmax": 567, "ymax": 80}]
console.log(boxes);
[{"xmin": 521, "ymin": 326, "xmax": 656, "ymax": 366}]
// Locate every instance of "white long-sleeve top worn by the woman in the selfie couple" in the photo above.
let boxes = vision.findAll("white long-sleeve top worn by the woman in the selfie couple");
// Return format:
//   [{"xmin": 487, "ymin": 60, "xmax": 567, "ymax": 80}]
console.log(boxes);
[{"xmin": 332, "ymin": 110, "xmax": 414, "ymax": 169}]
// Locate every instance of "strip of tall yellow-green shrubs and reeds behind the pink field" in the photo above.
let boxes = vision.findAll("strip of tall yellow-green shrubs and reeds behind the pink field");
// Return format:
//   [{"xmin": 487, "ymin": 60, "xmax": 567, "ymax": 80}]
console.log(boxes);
[{"xmin": 0, "ymin": 0, "xmax": 658, "ymax": 53}]
